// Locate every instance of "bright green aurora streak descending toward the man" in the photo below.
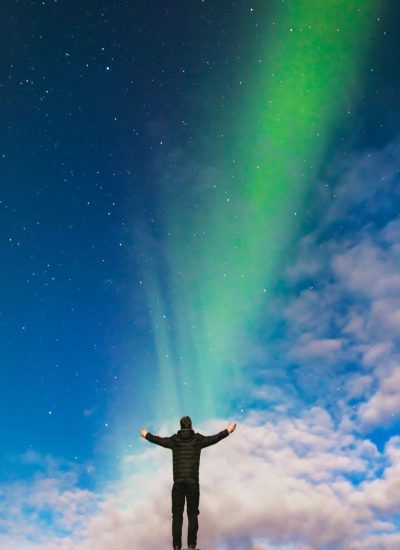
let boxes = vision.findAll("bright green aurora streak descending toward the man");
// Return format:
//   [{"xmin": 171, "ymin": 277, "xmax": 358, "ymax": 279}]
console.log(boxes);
[{"xmin": 138, "ymin": 0, "xmax": 377, "ymax": 422}]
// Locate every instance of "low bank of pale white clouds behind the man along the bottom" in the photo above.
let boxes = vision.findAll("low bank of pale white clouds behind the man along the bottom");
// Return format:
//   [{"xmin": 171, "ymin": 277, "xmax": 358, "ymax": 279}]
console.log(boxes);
[{"xmin": 0, "ymin": 416, "xmax": 400, "ymax": 550}]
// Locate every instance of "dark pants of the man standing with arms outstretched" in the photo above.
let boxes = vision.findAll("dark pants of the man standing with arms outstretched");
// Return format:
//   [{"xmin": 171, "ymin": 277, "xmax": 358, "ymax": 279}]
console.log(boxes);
[{"xmin": 172, "ymin": 479, "xmax": 200, "ymax": 548}]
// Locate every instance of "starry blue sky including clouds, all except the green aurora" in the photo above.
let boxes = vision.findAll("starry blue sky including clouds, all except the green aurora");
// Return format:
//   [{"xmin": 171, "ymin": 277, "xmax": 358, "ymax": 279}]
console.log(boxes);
[{"xmin": 0, "ymin": 1, "xmax": 400, "ymax": 550}]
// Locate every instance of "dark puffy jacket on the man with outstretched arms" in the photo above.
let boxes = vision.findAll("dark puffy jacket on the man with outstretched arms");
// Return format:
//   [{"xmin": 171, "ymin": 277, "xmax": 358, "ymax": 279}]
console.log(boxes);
[{"xmin": 146, "ymin": 428, "xmax": 229, "ymax": 482}]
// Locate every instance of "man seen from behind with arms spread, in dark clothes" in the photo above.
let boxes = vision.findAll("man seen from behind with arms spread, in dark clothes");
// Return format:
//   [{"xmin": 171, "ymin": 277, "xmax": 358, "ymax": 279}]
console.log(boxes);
[{"xmin": 140, "ymin": 416, "xmax": 236, "ymax": 550}]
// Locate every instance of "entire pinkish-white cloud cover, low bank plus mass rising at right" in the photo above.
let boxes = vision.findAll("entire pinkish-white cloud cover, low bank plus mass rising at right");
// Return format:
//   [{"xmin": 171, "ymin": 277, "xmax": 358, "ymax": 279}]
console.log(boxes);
[{"xmin": 1, "ymin": 114, "xmax": 400, "ymax": 550}]
